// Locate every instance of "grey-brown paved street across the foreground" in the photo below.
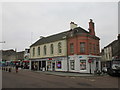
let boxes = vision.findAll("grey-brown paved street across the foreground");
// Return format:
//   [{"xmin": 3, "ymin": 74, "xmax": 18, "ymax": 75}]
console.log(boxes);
[{"xmin": 2, "ymin": 70, "xmax": 118, "ymax": 88}]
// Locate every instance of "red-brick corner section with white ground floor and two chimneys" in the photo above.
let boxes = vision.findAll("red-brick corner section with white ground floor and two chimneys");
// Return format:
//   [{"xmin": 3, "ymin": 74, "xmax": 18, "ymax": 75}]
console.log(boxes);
[{"xmin": 67, "ymin": 19, "xmax": 100, "ymax": 73}]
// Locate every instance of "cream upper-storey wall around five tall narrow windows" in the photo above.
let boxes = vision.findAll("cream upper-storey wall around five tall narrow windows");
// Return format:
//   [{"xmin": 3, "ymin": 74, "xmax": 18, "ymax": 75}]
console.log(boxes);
[{"xmin": 30, "ymin": 40, "xmax": 67, "ymax": 58}]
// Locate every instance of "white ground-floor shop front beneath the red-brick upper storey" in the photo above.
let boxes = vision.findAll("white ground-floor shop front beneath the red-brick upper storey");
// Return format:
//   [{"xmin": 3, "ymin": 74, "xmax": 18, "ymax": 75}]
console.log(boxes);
[{"xmin": 69, "ymin": 55, "xmax": 101, "ymax": 74}]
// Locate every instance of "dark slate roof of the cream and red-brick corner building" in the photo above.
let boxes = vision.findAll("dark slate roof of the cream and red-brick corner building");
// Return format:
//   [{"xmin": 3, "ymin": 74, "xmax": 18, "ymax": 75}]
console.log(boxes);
[{"xmin": 30, "ymin": 27, "xmax": 99, "ymax": 47}]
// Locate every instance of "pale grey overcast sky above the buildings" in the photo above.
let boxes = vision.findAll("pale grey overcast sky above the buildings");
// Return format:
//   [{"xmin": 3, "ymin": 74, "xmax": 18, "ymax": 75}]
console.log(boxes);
[{"xmin": 0, "ymin": 2, "xmax": 118, "ymax": 51}]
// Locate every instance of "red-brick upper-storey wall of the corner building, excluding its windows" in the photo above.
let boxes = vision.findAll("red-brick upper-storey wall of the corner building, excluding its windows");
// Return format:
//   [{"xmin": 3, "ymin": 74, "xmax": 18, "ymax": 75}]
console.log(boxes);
[{"xmin": 68, "ymin": 36, "xmax": 100, "ymax": 55}]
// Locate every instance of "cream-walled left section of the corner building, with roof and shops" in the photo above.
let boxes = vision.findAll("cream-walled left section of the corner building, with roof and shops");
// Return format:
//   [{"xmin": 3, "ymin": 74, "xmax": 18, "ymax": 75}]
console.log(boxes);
[{"xmin": 30, "ymin": 32, "xmax": 67, "ymax": 71}]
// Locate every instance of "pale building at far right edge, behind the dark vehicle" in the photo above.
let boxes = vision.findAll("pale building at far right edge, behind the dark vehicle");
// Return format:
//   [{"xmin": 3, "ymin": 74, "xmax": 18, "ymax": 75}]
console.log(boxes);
[{"xmin": 101, "ymin": 34, "xmax": 120, "ymax": 66}]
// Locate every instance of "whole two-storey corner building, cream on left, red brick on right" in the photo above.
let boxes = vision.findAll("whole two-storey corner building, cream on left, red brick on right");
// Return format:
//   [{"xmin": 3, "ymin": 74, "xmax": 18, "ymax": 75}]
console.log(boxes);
[{"xmin": 30, "ymin": 19, "xmax": 100, "ymax": 73}]
